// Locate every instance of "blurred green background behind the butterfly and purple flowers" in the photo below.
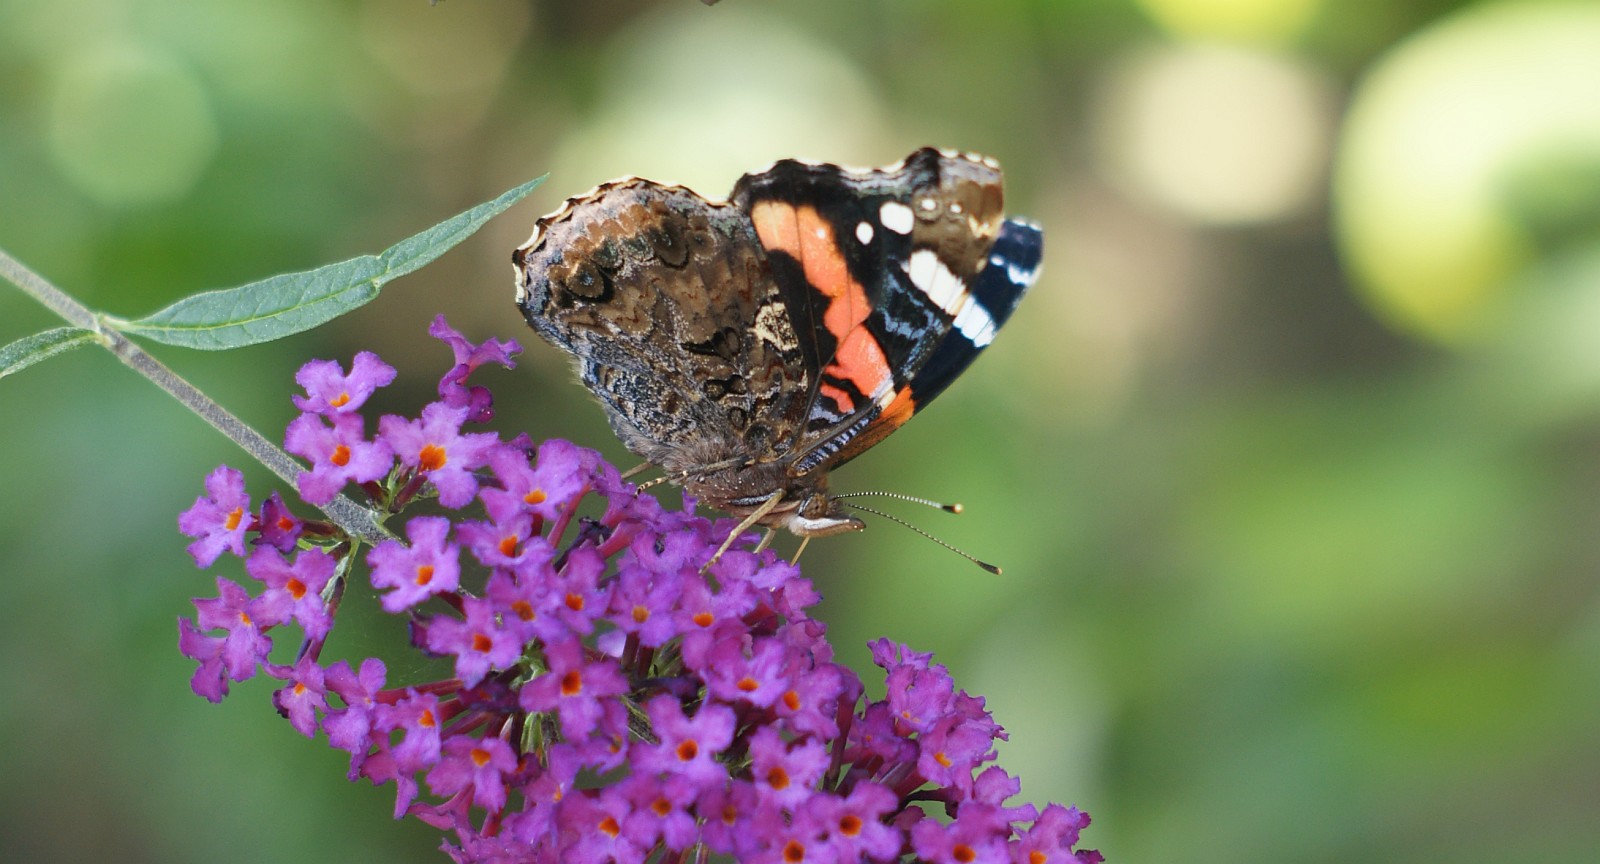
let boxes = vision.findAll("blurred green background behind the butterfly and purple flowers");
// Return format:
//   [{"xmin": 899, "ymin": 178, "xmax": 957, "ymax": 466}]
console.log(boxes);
[{"xmin": 0, "ymin": 0, "xmax": 1600, "ymax": 864}]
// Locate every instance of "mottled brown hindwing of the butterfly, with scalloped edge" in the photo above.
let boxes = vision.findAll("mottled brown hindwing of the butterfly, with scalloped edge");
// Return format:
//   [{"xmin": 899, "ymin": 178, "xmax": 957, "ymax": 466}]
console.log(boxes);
[{"xmin": 512, "ymin": 178, "xmax": 813, "ymax": 472}]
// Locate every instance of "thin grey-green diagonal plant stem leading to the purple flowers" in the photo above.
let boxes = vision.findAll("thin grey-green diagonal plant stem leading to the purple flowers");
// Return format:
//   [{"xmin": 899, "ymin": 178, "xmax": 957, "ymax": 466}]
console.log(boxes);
[{"xmin": 0, "ymin": 250, "xmax": 389, "ymax": 544}]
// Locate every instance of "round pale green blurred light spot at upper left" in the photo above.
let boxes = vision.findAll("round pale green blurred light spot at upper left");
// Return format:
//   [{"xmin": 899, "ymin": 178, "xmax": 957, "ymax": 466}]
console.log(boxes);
[{"xmin": 48, "ymin": 42, "xmax": 218, "ymax": 206}]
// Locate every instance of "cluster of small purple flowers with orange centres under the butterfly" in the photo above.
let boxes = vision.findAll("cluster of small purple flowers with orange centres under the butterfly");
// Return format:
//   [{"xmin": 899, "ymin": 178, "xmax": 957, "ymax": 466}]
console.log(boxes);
[{"xmin": 179, "ymin": 318, "xmax": 1101, "ymax": 864}]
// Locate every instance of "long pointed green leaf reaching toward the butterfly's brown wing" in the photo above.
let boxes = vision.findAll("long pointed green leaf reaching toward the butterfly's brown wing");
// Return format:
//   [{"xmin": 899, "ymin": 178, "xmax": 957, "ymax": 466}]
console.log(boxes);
[{"xmin": 112, "ymin": 174, "xmax": 547, "ymax": 350}]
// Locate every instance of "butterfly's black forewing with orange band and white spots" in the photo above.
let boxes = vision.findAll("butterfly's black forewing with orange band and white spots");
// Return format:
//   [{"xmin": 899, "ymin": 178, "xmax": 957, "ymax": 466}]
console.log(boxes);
[{"xmin": 731, "ymin": 149, "xmax": 1042, "ymax": 474}]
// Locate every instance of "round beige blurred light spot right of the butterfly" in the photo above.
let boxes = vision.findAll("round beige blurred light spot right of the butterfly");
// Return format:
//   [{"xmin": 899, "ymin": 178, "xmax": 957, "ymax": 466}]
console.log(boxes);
[{"xmin": 1093, "ymin": 43, "xmax": 1333, "ymax": 224}]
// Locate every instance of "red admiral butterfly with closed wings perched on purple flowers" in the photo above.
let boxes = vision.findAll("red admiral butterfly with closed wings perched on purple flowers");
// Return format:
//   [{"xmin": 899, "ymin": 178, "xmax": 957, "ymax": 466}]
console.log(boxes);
[{"xmin": 512, "ymin": 149, "xmax": 1043, "ymax": 556}]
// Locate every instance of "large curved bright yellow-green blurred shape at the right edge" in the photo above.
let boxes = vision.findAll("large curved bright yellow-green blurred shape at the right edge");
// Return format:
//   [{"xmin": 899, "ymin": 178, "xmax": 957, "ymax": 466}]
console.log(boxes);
[{"xmin": 1334, "ymin": 3, "xmax": 1600, "ymax": 342}]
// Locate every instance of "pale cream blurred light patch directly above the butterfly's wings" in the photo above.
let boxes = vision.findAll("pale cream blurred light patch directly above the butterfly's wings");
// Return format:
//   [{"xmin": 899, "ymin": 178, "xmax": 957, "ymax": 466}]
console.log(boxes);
[{"xmin": 550, "ymin": 3, "xmax": 906, "ymax": 198}]
